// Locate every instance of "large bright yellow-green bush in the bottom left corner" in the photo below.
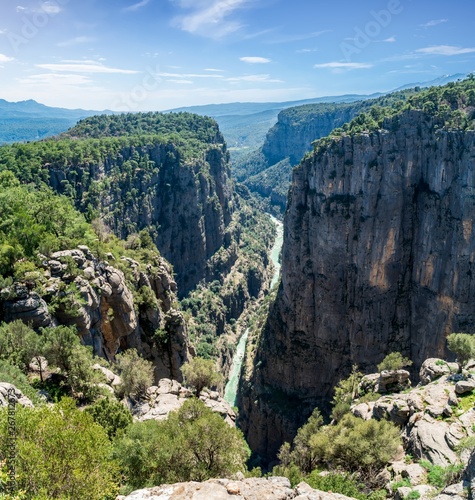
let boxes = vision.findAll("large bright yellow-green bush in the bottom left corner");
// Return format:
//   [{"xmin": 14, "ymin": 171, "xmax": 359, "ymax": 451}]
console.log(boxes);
[{"xmin": 0, "ymin": 398, "xmax": 118, "ymax": 500}]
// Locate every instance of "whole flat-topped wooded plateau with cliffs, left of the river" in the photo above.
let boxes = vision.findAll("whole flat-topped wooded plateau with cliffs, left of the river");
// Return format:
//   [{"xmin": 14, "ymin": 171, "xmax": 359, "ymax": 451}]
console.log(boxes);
[{"xmin": 0, "ymin": 113, "xmax": 273, "ymax": 371}]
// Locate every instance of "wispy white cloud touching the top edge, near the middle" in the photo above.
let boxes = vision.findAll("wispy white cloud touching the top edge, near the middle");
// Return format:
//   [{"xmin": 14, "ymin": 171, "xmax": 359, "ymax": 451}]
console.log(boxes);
[{"xmin": 173, "ymin": 0, "xmax": 249, "ymax": 38}]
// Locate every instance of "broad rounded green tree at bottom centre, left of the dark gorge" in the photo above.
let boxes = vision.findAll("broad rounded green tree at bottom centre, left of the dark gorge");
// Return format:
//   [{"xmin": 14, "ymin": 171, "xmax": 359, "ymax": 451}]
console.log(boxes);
[{"xmin": 114, "ymin": 398, "xmax": 250, "ymax": 488}]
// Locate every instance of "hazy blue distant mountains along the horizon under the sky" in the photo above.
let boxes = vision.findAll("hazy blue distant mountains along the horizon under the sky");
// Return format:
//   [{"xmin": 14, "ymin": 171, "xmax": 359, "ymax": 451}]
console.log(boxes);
[{"xmin": 0, "ymin": 73, "xmax": 466, "ymax": 146}]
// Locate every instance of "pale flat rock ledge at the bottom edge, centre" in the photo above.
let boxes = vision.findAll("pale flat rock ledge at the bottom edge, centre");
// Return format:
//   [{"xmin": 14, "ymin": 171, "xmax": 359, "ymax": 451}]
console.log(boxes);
[{"xmin": 119, "ymin": 477, "xmax": 356, "ymax": 500}]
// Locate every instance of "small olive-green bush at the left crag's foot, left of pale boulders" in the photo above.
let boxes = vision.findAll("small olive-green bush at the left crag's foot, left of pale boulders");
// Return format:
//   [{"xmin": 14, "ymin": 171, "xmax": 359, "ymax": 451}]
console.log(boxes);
[{"xmin": 116, "ymin": 349, "xmax": 153, "ymax": 398}]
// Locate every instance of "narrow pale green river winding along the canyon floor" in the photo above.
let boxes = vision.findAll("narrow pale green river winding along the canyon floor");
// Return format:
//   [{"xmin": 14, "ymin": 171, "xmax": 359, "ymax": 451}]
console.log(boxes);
[{"xmin": 224, "ymin": 215, "xmax": 284, "ymax": 406}]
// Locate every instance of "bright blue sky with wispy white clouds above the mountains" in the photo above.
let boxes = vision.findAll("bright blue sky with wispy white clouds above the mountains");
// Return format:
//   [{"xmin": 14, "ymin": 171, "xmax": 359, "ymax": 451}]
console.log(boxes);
[{"xmin": 0, "ymin": 0, "xmax": 475, "ymax": 111}]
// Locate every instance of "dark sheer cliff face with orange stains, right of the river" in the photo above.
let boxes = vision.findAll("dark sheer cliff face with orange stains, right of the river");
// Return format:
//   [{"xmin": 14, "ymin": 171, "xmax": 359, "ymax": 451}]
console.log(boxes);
[{"xmin": 242, "ymin": 111, "xmax": 475, "ymax": 457}]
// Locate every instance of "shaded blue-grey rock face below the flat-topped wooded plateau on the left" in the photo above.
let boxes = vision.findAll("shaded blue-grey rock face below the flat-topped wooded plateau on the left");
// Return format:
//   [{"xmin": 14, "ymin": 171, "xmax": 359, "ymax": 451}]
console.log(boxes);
[{"xmin": 49, "ymin": 143, "xmax": 234, "ymax": 295}]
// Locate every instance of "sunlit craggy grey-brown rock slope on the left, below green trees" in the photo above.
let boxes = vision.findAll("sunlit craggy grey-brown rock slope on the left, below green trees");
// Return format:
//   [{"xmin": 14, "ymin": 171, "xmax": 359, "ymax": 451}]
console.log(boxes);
[{"xmin": 0, "ymin": 246, "xmax": 189, "ymax": 380}]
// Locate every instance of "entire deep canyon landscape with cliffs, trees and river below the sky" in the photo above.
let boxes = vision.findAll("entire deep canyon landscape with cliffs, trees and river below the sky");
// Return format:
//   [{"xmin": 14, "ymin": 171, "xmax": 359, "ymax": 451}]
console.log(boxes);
[{"xmin": 0, "ymin": 75, "xmax": 475, "ymax": 500}]
